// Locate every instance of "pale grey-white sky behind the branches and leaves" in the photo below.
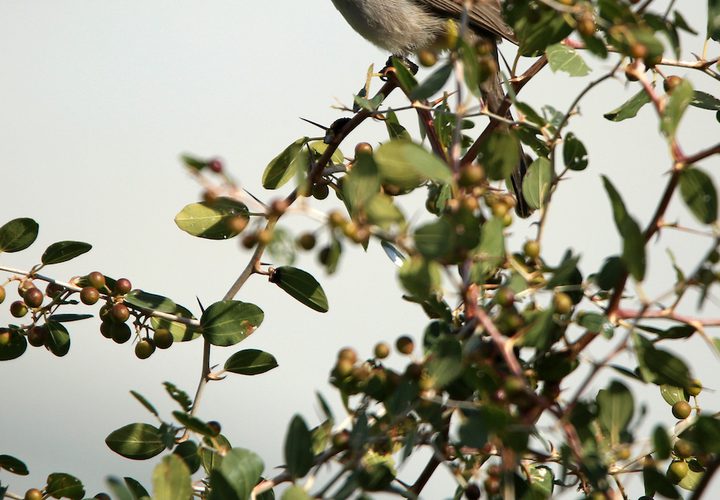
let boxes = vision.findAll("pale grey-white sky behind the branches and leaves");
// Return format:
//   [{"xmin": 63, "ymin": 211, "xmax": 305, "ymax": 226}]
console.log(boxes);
[{"xmin": 0, "ymin": 0, "xmax": 720, "ymax": 499}]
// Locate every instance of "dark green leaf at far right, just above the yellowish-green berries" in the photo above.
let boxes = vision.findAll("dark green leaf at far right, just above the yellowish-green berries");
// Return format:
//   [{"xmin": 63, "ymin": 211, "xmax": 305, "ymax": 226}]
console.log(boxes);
[{"xmin": 633, "ymin": 333, "xmax": 691, "ymax": 387}]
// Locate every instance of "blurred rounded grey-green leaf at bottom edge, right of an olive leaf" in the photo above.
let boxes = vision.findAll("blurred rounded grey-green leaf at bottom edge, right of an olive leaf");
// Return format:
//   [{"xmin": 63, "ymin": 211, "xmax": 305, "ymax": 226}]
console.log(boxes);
[{"xmin": 208, "ymin": 448, "xmax": 265, "ymax": 500}]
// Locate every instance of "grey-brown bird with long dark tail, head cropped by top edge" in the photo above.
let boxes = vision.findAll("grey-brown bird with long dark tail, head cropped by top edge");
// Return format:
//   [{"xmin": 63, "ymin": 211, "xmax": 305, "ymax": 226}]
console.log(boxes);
[{"xmin": 332, "ymin": 0, "xmax": 532, "ymax": 217}]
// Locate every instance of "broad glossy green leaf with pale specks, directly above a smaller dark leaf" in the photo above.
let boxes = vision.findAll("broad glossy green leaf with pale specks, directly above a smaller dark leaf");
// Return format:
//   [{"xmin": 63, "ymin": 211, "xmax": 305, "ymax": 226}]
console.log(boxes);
[{"xmin": 200, "ymin": 300, "xmax": 265, "ymax": 346}]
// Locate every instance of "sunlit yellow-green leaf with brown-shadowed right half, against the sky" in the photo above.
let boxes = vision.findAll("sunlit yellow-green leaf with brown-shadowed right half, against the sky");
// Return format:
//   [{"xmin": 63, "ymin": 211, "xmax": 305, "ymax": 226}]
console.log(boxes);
[{"xmin": 175, "ymin": 198, "xmax": 249, "ymax": 240}]
